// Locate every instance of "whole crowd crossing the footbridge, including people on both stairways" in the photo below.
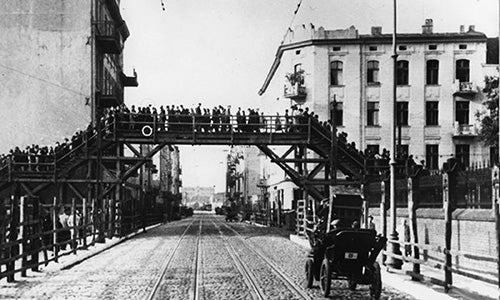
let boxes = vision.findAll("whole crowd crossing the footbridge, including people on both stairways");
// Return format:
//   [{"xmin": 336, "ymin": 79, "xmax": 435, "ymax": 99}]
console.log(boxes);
[{"xmin": 0, "ymin": 103, "xmax": 420, "ymax": 175}]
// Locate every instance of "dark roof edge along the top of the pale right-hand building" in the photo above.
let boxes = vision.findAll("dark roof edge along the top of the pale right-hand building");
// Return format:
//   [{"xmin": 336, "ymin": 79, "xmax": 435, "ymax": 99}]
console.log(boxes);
[{"xmin": 258, "ymin": 30, "xmax": 487, "ymax": 95}]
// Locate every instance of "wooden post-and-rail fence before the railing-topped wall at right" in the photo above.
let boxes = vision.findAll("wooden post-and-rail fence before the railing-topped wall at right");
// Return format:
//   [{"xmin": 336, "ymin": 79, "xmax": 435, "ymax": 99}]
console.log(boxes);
[{"xmin": 376, "ymin": 161, "xmax": 500, "ymax": 291}]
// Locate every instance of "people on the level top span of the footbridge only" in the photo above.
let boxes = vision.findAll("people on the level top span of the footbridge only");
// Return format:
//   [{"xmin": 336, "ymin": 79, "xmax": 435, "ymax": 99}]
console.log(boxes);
[{"xmin": 104, "ymin": 103, "xmax": 319, "ymax": 133}]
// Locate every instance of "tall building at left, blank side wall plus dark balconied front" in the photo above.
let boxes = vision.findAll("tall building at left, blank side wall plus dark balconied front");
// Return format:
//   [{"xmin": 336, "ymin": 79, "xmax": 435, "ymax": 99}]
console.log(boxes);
[{"xmin": 0, "ymin": 0, "xmax": 137, "ymax": 153}]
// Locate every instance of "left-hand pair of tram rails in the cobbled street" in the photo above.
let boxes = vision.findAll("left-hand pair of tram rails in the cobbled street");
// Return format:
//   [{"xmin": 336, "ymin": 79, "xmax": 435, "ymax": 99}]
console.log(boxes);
[{"xmin": 146, "ymin": 218, "xmax": 202, "ymax": 300}]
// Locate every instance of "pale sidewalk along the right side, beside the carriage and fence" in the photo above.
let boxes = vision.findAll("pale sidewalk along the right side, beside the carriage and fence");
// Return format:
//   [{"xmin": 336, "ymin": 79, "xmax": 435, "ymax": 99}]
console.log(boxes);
[{"xmin": 290, "ymin": 234, "xmax": 500, "ymax": 300}]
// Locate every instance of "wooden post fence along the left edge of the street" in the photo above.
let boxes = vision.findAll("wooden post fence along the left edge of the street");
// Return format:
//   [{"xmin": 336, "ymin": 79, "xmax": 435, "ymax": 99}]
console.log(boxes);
[{"xmin": 0, "ymin": 196, "xmax": 164, "ymax": 282}]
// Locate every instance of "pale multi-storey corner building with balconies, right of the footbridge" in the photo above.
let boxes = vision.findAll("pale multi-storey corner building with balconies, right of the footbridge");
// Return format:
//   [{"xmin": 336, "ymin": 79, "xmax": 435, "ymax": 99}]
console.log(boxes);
[{"xmin": 260, "ymin": 20, "xmax": 490, "ymax": 169}]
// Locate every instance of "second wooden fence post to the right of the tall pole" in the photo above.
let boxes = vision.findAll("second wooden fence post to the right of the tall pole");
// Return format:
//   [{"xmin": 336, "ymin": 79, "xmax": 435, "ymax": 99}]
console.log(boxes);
[{"xmin": 443, "ymin": 172, "xmax": 452, "ymax": 293}]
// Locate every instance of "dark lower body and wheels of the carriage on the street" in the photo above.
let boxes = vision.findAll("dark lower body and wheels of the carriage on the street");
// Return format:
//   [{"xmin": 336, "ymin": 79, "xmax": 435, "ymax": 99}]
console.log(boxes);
[{"xmin": 305, "ymin": 227, "xmax": 387, "ymax": 299}]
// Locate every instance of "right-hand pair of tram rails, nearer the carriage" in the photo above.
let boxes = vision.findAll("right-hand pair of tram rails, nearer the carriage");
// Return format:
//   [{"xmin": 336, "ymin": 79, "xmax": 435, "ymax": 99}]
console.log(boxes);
[{"xmin": 213, "ymin": 216, "xmax": 311, "ymax": 299}]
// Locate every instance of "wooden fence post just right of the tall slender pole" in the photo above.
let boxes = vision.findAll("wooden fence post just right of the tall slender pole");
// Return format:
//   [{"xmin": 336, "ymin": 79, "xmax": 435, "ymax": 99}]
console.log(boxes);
[{"xmin": 408, "ymin": 177, "xmax": 420, "ymax": 280}]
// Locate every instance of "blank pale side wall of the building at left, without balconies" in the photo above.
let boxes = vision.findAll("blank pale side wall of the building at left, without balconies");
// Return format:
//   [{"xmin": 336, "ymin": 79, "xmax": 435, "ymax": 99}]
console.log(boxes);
[{"xmin": 0, "ymin": 0, "xmax": 91, "ymax": 153}]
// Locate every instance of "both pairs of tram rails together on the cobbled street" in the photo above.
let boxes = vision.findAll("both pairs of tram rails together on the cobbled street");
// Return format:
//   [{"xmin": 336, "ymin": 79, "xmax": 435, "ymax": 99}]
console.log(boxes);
[{"xmin": 147, "ymin": 215, "xmax": 312, "ymax": 300}]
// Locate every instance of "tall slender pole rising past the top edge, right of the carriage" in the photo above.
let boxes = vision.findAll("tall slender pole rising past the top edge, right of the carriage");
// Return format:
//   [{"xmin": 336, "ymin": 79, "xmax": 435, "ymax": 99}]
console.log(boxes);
[{"xmin": 386, "ymin": 0, "xmax": 402, "ymax": 269}]
